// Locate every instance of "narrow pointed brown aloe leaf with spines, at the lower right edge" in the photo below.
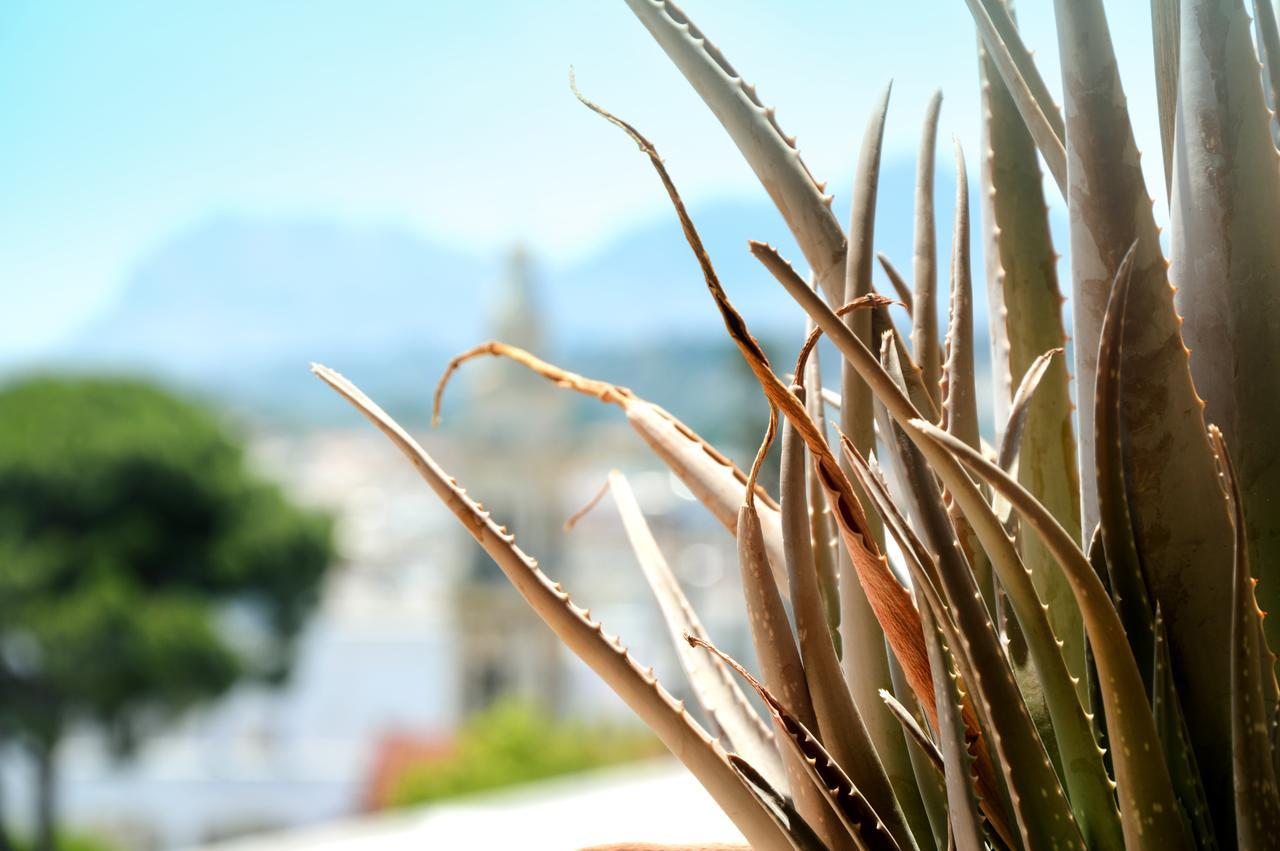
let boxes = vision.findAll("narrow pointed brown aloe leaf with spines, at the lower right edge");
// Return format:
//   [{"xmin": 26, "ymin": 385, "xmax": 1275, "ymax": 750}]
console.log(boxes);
[{"xmin": 1210, "ymin": 426, "xmax": 1280, "ymax": 848}]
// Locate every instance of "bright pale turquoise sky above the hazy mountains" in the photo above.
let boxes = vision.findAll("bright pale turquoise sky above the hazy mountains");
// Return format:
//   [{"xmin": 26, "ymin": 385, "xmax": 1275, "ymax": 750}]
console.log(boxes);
[{"xmin": 0, "ymin": 0, "xmax": 1161, "ymax": 360}]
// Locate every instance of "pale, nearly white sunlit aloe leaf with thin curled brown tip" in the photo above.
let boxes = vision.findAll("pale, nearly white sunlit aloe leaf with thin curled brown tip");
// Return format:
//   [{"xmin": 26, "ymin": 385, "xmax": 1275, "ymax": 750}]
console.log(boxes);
[{"xmin": 608, "ymin": 471, "xmax": 787, "ymax": 792}]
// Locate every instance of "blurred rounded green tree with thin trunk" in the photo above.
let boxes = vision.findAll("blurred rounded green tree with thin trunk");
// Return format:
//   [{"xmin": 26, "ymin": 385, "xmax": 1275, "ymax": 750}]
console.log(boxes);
[{"xmin": 0, "ymin": 378, "xmax": 333, "ymax": 851}]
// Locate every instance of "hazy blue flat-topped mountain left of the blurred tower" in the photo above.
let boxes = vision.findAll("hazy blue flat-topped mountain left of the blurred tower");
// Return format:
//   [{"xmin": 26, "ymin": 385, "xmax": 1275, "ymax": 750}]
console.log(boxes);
[{"xmin": 67, "ymin": 218, "xmax": 493, "ymax": 375}]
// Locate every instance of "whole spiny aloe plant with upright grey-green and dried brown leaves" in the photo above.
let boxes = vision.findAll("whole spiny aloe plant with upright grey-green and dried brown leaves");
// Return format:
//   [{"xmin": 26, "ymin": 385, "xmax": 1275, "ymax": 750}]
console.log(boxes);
[{"xmin": 315, "ymin": 0, "xmax": 1280, "ymax": 851}]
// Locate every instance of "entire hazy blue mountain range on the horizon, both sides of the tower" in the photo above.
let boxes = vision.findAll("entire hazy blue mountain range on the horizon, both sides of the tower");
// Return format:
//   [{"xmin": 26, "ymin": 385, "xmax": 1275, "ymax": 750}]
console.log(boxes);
[{"xmin": 49, "ymin": 161, "xmax": 1034, "ymax": 422}]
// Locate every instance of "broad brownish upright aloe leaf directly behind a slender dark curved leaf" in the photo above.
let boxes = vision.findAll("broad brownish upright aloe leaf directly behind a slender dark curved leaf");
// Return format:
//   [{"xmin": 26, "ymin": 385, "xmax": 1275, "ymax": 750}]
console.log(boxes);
[{"xmin": 1055, "ymin": 0, "xmax": 1239, "ymax": 824}]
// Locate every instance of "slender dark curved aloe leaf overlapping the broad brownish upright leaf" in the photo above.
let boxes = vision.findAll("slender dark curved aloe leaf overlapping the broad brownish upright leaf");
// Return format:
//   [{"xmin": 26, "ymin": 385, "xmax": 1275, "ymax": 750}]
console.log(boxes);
[{"xmin": 1093, "ymin": 250, "xmax": 1155, "ymax": 695}]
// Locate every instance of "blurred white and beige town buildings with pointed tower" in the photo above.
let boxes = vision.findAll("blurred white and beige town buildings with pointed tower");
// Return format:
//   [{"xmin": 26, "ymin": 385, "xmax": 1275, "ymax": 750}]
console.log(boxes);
[{"xmin": 4, "ymin": 241, "xmax": 778, "ymax": 848}]
